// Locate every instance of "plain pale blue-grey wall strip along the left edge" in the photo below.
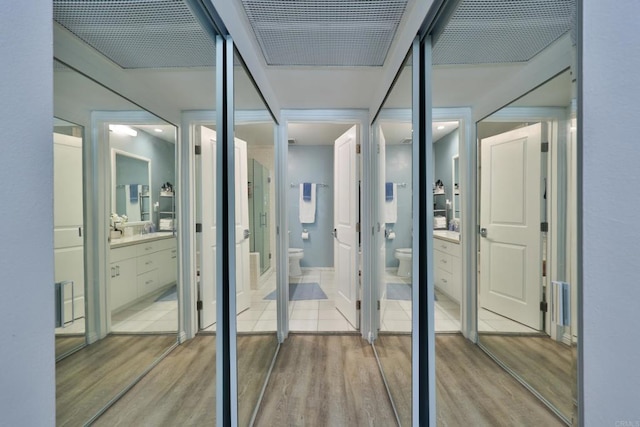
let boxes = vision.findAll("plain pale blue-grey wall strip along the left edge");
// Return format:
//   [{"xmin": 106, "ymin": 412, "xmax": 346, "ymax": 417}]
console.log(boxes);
[{"xmin": 0, "ymin": 0, "xmax": 55, "ymax": 426}]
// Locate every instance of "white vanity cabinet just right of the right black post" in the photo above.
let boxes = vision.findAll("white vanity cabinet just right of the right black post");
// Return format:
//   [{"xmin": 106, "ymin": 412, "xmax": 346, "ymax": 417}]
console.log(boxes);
[{"xmin": 433, "ymin": 230, "xmax": 462, "ymax": 302}]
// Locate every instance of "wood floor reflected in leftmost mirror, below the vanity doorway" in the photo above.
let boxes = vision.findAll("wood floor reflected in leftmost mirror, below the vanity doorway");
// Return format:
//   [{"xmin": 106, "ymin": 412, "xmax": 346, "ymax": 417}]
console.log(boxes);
[{"xmin": 56, "ymin": 335, "xmax": 176, "ymax": 426}]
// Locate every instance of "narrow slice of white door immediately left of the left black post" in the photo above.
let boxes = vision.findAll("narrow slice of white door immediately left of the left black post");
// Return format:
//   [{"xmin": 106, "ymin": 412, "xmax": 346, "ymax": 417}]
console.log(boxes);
[{"xmin": 199, "ymin": 126, "xmax": 217, "ymax": 329}]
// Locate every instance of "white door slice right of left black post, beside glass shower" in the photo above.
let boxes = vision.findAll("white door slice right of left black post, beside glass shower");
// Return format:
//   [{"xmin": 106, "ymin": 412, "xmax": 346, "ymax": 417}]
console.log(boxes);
[{"xmin": 234, "ymin": 138, "xmax": 251, "ymax": 313}]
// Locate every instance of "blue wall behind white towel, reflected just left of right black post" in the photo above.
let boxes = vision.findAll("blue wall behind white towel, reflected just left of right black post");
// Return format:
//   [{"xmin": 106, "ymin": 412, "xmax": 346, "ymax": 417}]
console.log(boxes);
[{"xmin": 385, "ymin": 144, "xmax": 413, "ymax": 267}]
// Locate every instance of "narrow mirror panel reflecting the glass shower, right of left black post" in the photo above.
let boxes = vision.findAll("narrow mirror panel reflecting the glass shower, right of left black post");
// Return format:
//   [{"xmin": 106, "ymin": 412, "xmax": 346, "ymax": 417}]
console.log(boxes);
[{"xmin": 233, "ymin": 46, "xmax": 278, "ymax": 426}]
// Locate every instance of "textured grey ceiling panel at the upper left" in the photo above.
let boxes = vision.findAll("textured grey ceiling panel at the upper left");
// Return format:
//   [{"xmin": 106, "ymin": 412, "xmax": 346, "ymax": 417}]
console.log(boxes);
[{"xmin": 53, "ymin": 0, "xmax": 215, "ymax": 68}]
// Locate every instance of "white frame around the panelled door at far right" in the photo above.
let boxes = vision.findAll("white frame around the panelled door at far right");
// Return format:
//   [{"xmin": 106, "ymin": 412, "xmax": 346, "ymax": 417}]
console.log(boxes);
[{"xmin": 473, "ymin": 106, "xmax": 569, "ymax": 335}]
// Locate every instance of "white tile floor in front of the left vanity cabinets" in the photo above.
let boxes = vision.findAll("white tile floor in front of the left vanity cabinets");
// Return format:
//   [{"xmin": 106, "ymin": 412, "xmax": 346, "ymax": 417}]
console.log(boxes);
[{"xmin": 111, "ymin": 288, "xmax": 178, "ymax": 333}]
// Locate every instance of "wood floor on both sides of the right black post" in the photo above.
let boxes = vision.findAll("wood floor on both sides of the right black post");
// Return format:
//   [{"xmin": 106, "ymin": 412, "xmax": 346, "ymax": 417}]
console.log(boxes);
[{"xmin": 376, "ymin": 334, "xmax": 564, "ymax": 426}]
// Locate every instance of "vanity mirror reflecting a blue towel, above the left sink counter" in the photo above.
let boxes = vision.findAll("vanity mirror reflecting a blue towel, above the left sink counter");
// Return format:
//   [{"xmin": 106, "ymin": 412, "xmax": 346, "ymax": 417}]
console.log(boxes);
[{"xmin": 111, "ymin": 150, "xmax": 153, "ymax": 223}]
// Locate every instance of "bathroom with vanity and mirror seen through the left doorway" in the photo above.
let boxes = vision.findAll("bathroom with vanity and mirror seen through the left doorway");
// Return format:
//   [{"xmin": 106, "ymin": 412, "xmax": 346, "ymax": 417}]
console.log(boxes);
[{"xmin": 108, "ymin": 124, "xmax": 178, "ymax": 332}]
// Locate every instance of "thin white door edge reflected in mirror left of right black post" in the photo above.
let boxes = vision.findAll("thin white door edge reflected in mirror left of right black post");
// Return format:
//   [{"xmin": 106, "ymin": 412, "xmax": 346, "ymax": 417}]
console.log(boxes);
[{"xmin": 377, "ymin": 126, "xmax": 387, "ymax": 329}]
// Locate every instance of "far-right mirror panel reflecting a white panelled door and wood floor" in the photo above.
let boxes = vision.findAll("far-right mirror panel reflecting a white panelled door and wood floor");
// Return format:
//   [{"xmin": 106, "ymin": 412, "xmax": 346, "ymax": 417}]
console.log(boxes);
[{"xmin": 477, "ymin": 69, "xmax": 579, "ymax": 423}]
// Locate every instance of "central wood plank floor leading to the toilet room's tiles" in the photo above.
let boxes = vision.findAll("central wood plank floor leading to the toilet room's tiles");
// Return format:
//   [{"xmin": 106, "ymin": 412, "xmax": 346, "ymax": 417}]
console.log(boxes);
[{"xmin": 255, "ymin": 334, "xmax": 396, "ymax": 426}]
